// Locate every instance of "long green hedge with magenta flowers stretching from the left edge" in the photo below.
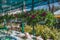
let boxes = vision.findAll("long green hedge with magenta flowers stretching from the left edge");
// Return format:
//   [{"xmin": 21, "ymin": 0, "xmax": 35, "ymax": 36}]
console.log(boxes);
[{"xmin": 0, "ymin": 10, "xmax": 55, "ymax": 26}]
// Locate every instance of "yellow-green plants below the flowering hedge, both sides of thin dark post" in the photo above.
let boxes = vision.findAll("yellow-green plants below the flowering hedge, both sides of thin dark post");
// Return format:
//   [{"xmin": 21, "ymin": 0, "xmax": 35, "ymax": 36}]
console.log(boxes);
[{"xmin": 24, "ymin": 24, "xmax": 60, "ymax": 40}]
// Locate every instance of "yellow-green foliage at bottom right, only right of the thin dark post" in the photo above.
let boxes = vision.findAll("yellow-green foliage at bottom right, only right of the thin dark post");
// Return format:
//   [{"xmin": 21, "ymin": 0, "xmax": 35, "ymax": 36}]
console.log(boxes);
[{"xmin": 36, "ymin": 25, "xmax": 58, "ymax": 40}]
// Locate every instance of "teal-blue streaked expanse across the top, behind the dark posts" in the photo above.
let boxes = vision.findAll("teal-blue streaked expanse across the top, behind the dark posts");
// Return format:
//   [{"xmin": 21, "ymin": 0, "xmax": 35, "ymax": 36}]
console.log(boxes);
[{"xmin": 0, "ymin": 0, "xmax": 58, "ymax": 13}]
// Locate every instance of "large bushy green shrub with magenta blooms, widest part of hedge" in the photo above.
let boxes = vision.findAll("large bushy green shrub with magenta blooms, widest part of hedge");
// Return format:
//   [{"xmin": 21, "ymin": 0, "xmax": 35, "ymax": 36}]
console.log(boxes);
[{"xmin": 21, "ymin": 10, "xmax": 55, "ymax": 25}]
